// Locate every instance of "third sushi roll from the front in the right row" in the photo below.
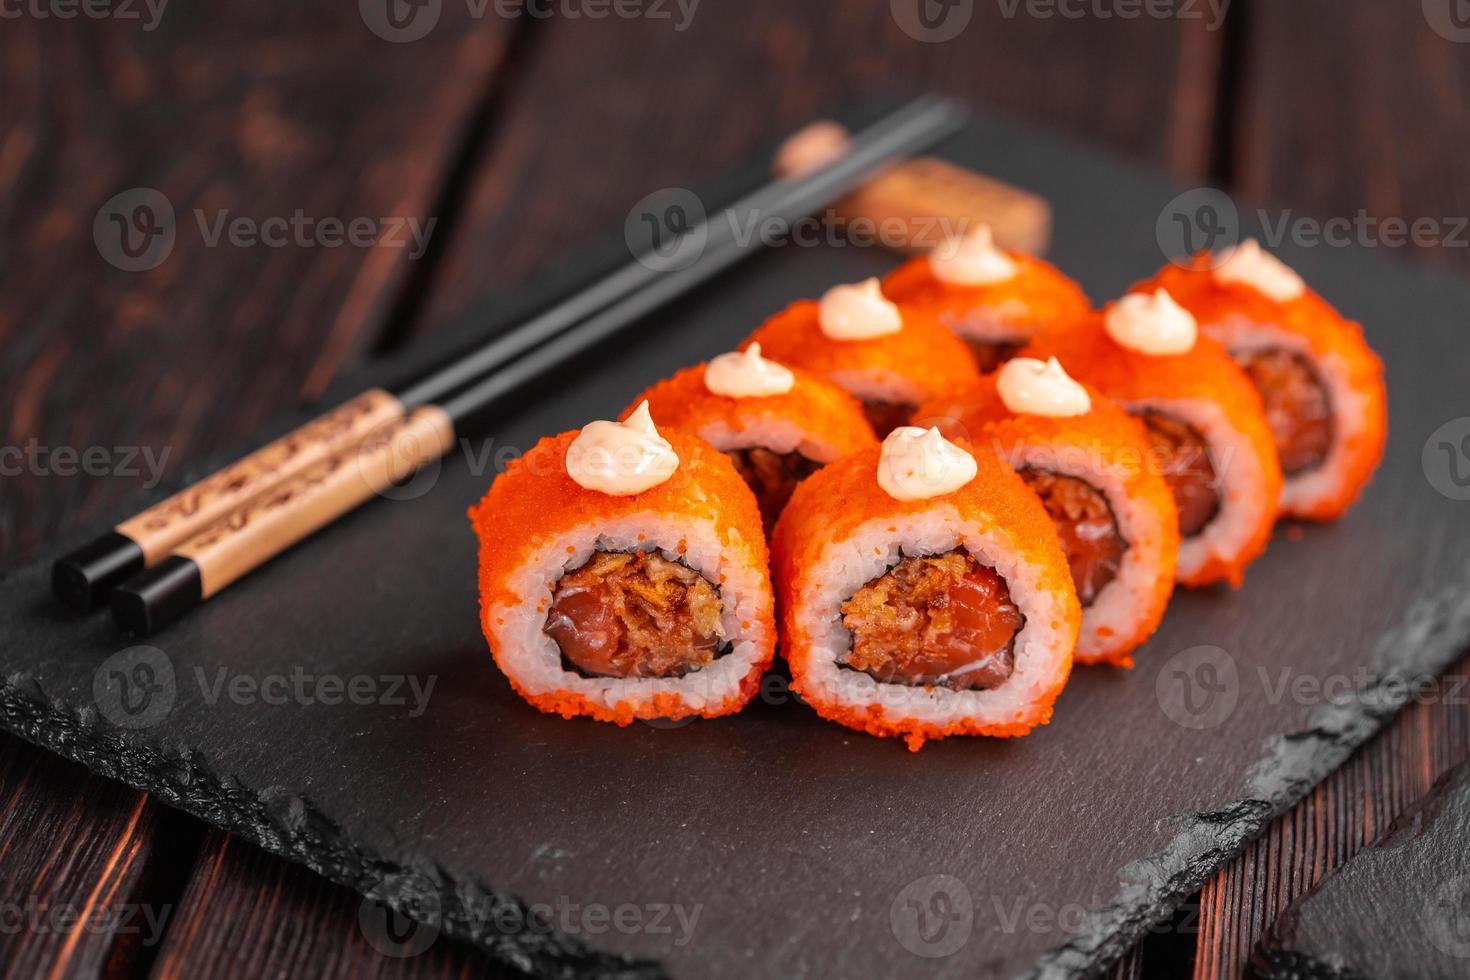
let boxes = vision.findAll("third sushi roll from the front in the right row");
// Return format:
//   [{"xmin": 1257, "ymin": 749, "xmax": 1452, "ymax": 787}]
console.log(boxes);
[{"xmin": 1025, "ymin": 289, "xmax": 1282, "ymax": 586}]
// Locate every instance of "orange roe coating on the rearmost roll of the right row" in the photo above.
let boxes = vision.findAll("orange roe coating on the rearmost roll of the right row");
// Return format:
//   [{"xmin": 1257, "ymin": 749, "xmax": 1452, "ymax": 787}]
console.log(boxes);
[{"xmin": 1135, "ymin": 256, "xmax": 1388, "ymax": 520}]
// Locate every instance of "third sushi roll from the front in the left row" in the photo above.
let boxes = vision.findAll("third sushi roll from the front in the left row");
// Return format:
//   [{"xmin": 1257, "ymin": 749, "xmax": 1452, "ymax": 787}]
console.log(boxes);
[{"xmin": 741, "ymin": 279, "xmax": 979, "ymax": 438}]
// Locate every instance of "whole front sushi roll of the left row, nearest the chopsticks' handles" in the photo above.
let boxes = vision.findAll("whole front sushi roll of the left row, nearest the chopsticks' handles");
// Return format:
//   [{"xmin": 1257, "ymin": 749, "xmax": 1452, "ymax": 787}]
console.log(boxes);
[{"xmin": 470, "ymin": 404, "xmax": 775, "ymax": 724}]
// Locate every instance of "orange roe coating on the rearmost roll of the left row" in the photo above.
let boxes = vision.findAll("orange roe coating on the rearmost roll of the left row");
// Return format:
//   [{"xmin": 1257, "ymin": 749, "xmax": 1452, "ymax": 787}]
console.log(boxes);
[{"xmin": 883, "ymin": 251, "xmax": 1092, "ymax": 345}]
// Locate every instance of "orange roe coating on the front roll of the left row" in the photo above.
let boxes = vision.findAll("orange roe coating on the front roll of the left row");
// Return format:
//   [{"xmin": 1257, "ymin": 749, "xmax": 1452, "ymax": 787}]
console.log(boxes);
[{"xmin": 469, "ymin": 429, "xmax": 776, "ymax": 724}]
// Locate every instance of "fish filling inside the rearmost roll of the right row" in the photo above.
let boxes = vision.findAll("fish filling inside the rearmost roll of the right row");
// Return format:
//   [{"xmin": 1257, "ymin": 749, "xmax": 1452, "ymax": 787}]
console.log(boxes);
[{"xmin": 1235, "ymin": 348, "xmax": 1332, "ymax": 476}]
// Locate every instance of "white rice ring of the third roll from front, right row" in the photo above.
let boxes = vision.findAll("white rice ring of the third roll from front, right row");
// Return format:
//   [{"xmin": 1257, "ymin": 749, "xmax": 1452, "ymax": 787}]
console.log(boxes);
[{"xmin": 1123, "ymin": 398, "xmax": 1273, "ymax": 579}]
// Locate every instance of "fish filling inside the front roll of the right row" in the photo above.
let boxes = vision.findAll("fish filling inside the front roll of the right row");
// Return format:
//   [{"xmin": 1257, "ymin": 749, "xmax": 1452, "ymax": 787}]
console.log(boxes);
[{"xmin": 842, "ymin": 550, "xmax": 1026, "ymax": 691}]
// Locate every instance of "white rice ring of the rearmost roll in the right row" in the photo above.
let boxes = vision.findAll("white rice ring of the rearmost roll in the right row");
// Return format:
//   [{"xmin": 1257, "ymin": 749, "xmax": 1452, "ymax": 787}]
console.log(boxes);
[{"xmin": 1201, "ymin": 313, "xmax": 1372, "ymax": 510}]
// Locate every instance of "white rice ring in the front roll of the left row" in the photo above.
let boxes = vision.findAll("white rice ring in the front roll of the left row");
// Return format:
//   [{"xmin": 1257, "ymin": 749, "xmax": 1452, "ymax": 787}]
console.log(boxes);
[{"xmin": 485, "ymin": 513, "xmax": 772, "ymax": 717}]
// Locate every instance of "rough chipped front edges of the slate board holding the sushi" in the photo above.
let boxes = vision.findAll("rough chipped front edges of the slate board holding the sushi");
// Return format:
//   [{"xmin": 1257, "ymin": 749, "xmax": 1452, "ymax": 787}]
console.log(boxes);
[{"xmin": 11, "ymin": 566, "xmax": 1470, "ymax": 980}]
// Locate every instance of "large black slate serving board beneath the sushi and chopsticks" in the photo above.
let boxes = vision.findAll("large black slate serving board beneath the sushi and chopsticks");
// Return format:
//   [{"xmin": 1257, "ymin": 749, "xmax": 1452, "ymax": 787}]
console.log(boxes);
[{"xmin": 0, "ymin": 109, "xmax": 1470, "ymax": 977}]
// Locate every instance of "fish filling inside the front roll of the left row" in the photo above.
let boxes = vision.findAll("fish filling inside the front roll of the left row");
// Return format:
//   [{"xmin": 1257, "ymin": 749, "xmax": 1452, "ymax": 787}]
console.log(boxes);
[{"xmin": 542, "ymin": 551, "xmax": 723, "ymax": 677}]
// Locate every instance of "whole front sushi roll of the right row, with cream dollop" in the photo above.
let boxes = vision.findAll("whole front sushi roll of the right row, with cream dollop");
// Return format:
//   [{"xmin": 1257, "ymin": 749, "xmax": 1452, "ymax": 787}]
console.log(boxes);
[{"xmin": 772, "ymin": 426, "xmax": 1082, "ymax": 751}]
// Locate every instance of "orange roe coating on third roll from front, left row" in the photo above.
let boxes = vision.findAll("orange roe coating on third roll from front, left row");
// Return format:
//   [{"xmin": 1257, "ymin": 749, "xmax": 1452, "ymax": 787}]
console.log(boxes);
[{"xmin": 739, "ymin": 300, "xmax": 980, "ymax": 401}]
